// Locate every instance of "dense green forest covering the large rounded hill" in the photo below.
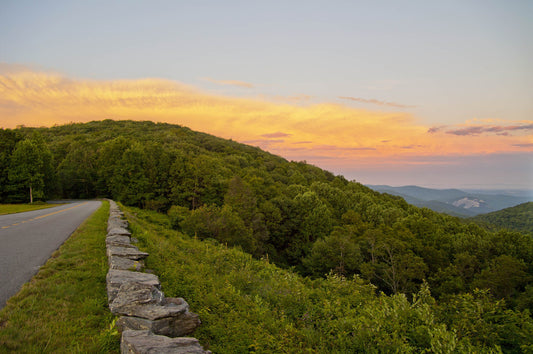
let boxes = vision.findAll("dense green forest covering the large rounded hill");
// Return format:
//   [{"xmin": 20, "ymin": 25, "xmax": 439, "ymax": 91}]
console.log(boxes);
[{"xmin": 0, "ymin": 120, "xmax": 533, "ymax": 310}]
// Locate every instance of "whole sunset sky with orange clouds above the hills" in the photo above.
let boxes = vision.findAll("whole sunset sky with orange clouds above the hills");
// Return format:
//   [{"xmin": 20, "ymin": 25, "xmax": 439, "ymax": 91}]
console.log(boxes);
[{"xmin": 0, "ymin": 0, "xmax": 533, "ymax": 189}]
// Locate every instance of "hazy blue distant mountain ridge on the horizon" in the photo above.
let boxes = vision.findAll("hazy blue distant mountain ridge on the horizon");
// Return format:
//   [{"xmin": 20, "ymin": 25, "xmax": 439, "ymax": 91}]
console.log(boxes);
[{"xmin": 367, "ymin": 185, "xmax": 533, "ymax": 217}]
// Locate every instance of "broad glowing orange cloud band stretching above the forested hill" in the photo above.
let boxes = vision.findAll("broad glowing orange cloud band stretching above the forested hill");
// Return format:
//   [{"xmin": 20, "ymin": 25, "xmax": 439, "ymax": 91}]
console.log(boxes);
[{"xmin": 0, "ymin": 67, "xmax": 533, "ymax": 169}]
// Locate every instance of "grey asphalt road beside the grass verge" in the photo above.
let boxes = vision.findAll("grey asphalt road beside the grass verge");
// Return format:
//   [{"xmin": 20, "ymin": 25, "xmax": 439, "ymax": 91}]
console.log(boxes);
[{"xmin": 0, "ymin": 201, "xmax": 101, "ymax": 308}]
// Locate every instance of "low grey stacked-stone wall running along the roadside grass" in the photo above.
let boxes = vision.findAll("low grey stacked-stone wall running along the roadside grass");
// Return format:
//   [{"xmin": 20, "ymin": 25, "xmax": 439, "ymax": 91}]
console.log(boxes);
[{"xmin": 106, "ymin": 201, "xmax": 210, "ymax": 353}]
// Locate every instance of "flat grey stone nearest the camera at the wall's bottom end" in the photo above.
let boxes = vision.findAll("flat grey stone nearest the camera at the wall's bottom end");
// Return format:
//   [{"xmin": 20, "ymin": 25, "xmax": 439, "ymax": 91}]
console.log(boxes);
[{"xmin": 120, "ymin": 330, "xmax": 210, "ymax": 354}]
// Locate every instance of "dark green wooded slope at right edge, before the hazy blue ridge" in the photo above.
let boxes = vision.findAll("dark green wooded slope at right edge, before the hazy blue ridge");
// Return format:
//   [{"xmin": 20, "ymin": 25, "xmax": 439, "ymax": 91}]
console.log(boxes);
[{"xmin": 471, "ymin": 202, "xmax": 533, "ymax": 235}]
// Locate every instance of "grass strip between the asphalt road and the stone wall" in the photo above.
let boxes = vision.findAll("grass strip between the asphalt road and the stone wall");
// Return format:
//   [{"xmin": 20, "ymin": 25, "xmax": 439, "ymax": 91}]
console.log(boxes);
[{"xmin": 0, "ymin": 202, "xmax": 120, "ymax": 353}]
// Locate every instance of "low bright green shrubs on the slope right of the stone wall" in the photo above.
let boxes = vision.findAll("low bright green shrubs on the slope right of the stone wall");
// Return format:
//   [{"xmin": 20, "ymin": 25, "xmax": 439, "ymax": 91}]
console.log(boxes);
[{"xmin": 125, "ymin": 208, "xmax": 533, "ymax": 353}]
